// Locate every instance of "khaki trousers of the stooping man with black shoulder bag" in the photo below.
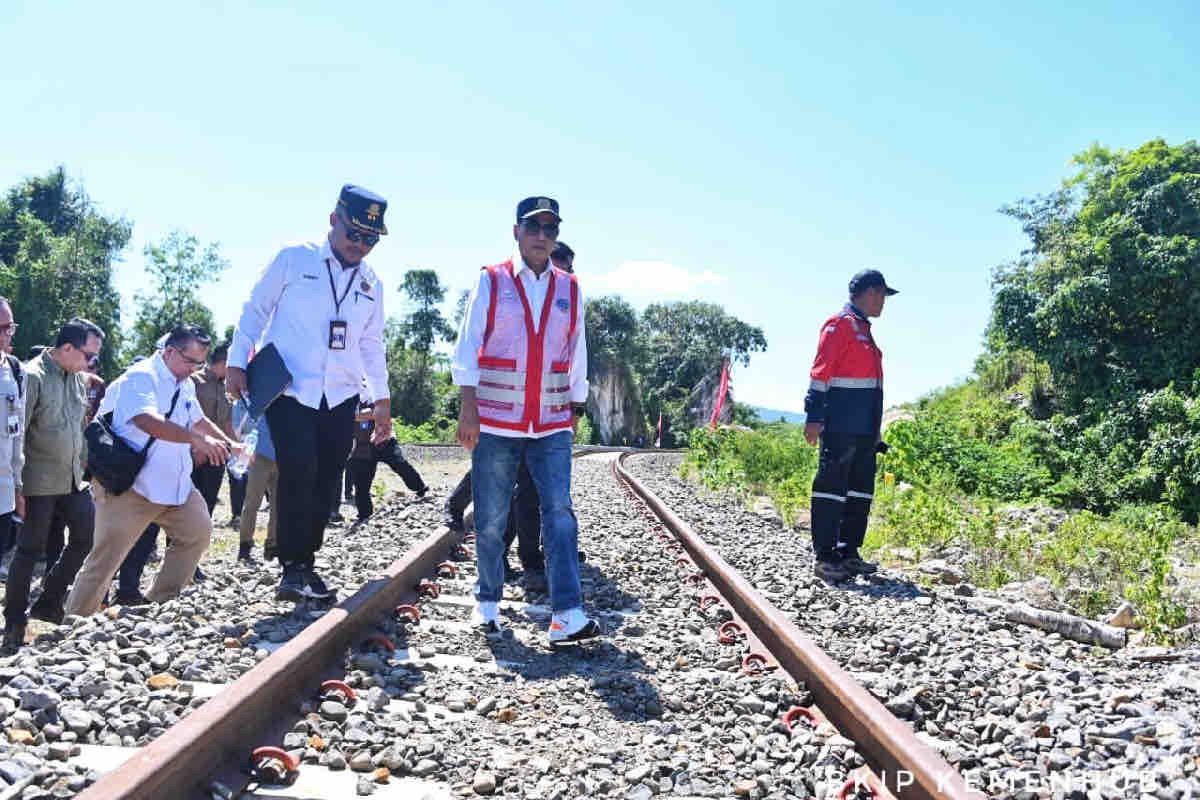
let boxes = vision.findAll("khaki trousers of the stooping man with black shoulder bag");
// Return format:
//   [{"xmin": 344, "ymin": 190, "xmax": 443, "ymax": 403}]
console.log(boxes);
[{"xmin": 66, "ymin": 483, "xmax": 212, "ymax": 616}]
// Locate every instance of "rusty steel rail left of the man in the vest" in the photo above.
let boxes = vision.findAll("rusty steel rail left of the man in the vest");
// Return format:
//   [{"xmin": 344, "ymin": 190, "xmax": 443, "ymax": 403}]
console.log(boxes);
[{"xmin": 78, "ymin": 528, "xmax": 458, "ymax": 800}]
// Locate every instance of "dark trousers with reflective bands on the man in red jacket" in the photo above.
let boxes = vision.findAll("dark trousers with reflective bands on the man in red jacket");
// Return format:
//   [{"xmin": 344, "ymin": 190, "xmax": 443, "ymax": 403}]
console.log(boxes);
[{"xmin": 812, "ymin": 433, "xmax": 876, "ymax": 560}]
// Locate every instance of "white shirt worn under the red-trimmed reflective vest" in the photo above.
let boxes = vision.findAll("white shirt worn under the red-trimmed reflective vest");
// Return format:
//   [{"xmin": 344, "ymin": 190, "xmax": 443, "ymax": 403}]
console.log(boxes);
[{"xmin": 450, "ymin": 252, "xmax": 588, "ymax": 439}]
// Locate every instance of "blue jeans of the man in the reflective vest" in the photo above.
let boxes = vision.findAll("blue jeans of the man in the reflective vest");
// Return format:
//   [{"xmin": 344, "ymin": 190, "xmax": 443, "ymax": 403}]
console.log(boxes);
[{"xmin": 470, "ymin": 431, "xmax": 583, "ymax": 612}]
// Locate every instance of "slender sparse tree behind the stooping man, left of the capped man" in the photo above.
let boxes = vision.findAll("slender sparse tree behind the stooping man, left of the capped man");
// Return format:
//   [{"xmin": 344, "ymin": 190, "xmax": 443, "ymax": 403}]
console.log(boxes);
[{"xmin": 128, "ymin": 230, "xmax": 229, "ymax": 357}]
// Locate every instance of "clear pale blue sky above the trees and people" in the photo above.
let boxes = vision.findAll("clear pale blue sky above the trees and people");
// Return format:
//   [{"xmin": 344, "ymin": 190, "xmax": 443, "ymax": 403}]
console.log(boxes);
[{"xmin": 0, "ymin": 0, "xmax": 1200, "ymax": 409}]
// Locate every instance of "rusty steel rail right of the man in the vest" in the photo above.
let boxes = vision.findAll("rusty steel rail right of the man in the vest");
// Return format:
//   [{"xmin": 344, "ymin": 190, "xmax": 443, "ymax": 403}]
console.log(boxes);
[{"xmin": 613, "ymin": 453, "xmax": 984, "ymax": 800}]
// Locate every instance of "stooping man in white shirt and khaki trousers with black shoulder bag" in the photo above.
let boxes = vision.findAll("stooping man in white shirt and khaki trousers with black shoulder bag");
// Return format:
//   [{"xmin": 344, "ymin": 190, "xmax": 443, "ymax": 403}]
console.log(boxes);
[{"xmin": 65, "ymin": 325, "xmax": 236, "ymax": 616}]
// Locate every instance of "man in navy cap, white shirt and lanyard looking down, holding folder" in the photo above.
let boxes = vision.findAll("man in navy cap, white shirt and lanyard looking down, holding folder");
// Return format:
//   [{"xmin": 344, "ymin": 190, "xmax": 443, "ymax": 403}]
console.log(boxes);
[{"xmin": 226, "ymin": 184, "xmax": 391, "ymax": 602}]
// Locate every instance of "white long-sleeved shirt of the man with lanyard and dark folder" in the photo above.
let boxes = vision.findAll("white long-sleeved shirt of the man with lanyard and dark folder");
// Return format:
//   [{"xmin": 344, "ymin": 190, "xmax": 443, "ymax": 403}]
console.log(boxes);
[{"xmin": 229, "ymin": 239, "xmax": 390, "ymax": 408}]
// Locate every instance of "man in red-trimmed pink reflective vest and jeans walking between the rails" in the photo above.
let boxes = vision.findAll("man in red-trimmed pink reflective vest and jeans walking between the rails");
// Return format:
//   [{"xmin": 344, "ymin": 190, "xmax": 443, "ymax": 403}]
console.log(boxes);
[{"xmin": 451, "ymin": 197, "xmax": 600, "ymax": 645}]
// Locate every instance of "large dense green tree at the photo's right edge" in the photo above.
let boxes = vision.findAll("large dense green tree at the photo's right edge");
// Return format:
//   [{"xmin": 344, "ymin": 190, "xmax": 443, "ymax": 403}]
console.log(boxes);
[{"xmin": 989, "ymin": 139, "xmax": 1200, "ymax": 416}]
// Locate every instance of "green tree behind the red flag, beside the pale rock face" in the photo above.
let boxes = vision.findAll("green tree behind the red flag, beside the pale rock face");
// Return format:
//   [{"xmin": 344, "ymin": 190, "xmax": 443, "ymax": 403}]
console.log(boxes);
[{"xmin": 636, "ymin": 300, "xmax": 767, "ymax": 446}]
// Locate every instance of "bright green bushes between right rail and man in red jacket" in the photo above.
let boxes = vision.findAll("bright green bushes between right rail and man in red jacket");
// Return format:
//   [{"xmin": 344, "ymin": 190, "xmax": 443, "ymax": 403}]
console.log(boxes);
[{"xmin": 683, "ymin": 422, "xmax": 817, "ymax": 523}]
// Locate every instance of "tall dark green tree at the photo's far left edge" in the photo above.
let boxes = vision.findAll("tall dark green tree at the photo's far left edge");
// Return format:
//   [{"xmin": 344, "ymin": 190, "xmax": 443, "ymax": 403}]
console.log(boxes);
[{"xmin": 0, "ymin": 167, "xmax": 131, "ymax": 378}]
